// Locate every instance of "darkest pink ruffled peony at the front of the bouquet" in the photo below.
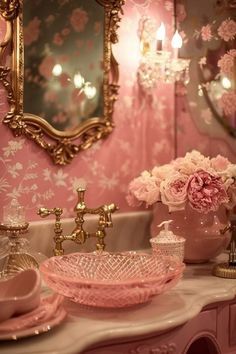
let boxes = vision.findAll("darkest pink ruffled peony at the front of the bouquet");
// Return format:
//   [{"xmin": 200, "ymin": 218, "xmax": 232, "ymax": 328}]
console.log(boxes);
[{"xmin": 187, "ymin": 170, "xmax": 229, "ymax": 214}]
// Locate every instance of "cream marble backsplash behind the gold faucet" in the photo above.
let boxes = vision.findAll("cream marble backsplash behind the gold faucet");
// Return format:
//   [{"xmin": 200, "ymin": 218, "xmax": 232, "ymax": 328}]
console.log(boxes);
[{"xmin": 28, "ymin": 211, "xmax": 152, "ymax": 257}]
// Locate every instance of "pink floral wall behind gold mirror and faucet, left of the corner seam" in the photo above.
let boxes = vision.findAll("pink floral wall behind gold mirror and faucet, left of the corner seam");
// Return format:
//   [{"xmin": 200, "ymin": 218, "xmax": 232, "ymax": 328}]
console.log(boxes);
[{"xmin": 0, "ymin": 0, "xmax": 174, "ymax": 220}]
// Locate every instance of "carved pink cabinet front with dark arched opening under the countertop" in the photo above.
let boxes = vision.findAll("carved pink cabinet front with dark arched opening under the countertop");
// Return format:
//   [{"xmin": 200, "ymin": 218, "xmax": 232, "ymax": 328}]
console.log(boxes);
[{"xmin": 85, "ymin": 309, "xmax": 218, "ymax": 354}]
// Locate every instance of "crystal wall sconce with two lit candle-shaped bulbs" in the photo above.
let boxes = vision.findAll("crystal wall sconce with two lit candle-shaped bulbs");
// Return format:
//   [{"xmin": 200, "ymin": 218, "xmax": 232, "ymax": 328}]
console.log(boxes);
[{"xmin": 138, "ymin": 17, "xmax": 190, "ymax": 89}]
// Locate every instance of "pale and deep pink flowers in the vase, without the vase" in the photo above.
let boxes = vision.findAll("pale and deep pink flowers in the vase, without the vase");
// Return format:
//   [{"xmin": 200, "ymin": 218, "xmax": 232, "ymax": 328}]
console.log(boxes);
[{"xmin": 127, "ymin": 150, "xmax": 236, "ymax": 214}]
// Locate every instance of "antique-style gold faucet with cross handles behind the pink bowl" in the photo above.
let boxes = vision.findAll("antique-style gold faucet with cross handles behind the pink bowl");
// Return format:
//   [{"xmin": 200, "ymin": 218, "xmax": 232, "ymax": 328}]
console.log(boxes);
[{"xmin": 38, "ymin": 188, "xmax": 118, "ymax": 256}]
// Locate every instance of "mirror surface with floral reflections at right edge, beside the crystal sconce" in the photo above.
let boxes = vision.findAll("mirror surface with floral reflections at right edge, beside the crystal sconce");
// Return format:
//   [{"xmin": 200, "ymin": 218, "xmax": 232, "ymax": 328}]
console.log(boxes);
[{"xmin": 181, "ymin": 0, "xmax": 236, "ymax": 137}]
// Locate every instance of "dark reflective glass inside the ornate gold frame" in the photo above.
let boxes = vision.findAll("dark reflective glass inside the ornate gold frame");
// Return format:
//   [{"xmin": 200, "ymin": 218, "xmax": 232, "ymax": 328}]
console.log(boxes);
[{"xmin": 23, "ymin": 0, "xmax": 104, "ymax": 131}]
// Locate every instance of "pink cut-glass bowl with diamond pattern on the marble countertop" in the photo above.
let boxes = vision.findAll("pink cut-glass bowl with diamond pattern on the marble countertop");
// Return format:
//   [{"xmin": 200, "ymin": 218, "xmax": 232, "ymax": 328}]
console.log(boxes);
[{"xmin": 40, "ymin": 252, "xmax": 184, "ymax": 308}]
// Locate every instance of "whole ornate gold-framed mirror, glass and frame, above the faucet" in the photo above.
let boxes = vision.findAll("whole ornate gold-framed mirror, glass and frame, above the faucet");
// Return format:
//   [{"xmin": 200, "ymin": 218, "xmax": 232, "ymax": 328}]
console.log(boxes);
[{"xmin": 0, "ymin": 0, "xmax": 124, "ymax": 165}]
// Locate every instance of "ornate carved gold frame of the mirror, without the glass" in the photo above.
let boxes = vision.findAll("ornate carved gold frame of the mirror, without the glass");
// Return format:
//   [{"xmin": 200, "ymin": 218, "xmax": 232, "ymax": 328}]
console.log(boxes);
[{"xmin": 0, "ymin": 0, "xmax": 124, "ymax": 165}]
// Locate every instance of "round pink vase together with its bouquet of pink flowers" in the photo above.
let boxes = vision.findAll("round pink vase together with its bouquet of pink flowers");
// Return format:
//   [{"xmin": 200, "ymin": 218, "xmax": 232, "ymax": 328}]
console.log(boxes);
[{"xmin": 127, "ymin": 150, "xmax": 236, "ymax": 263}]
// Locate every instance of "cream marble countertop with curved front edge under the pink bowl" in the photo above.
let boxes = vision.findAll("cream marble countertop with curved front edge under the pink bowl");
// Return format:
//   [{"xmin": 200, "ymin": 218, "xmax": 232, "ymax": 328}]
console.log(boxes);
[{"xmin": 0, "ymin": 257, "xmax": 236, "ymax": 354}]
